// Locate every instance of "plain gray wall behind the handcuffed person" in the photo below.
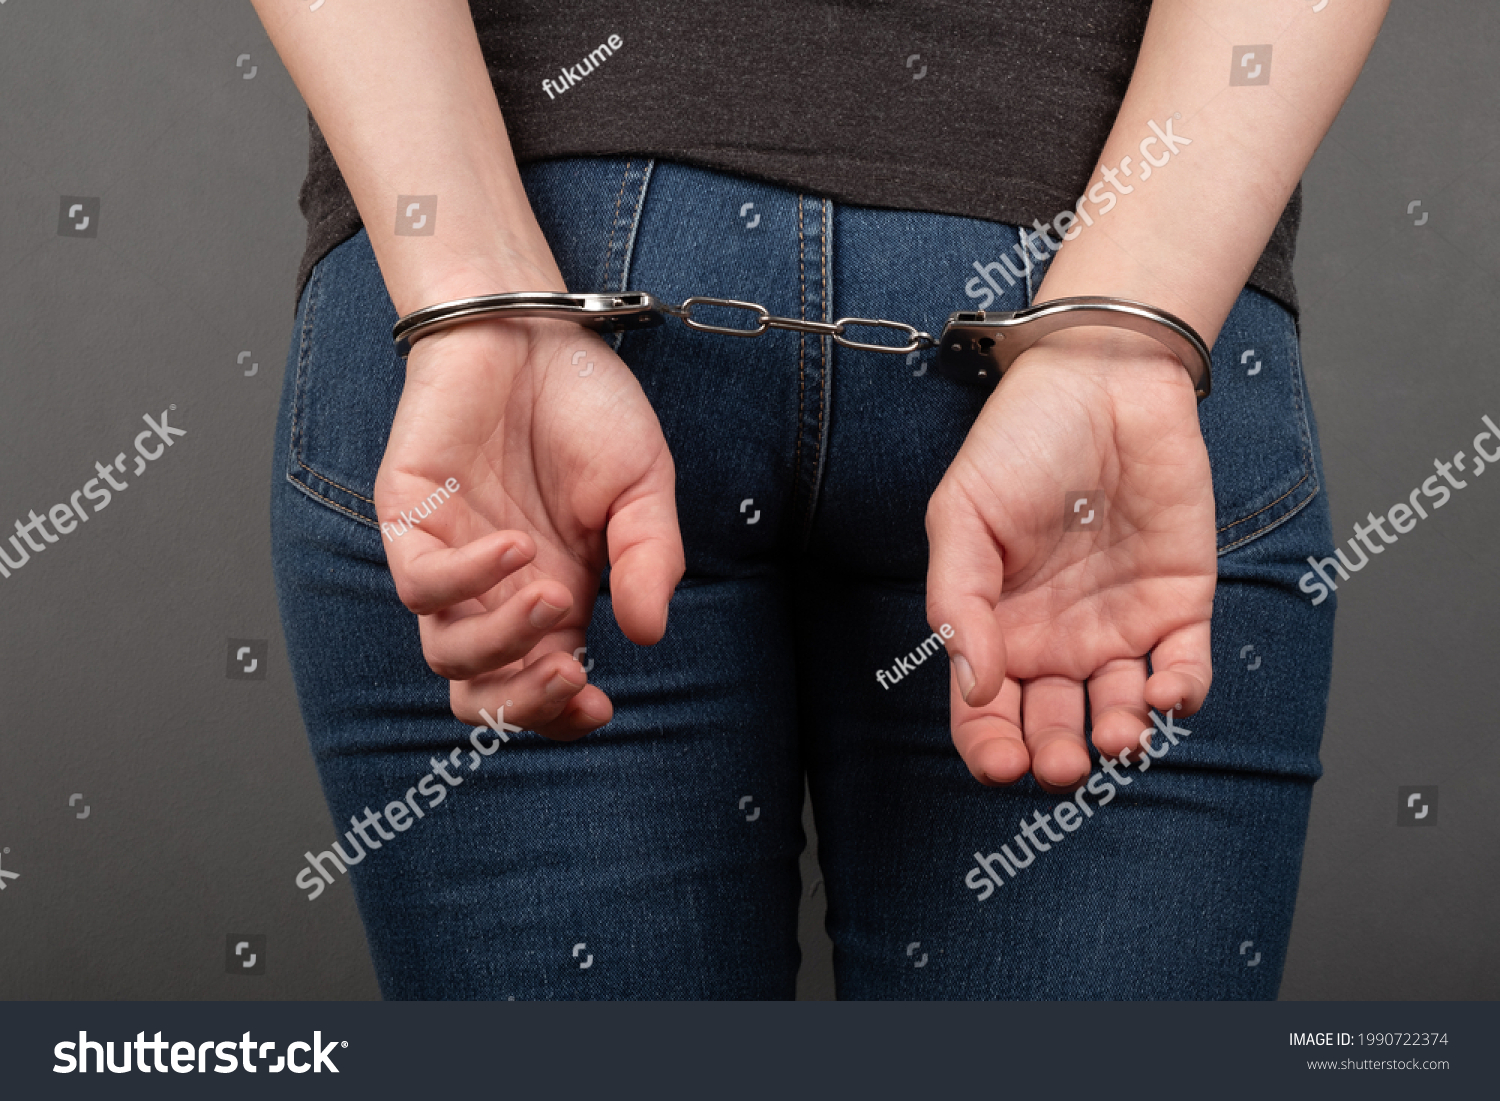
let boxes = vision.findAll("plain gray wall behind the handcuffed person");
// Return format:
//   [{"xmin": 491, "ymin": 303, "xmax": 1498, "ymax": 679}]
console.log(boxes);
[{"xmin": 0, "ymin": 0, "xmax": 1500, "ymax": 999}]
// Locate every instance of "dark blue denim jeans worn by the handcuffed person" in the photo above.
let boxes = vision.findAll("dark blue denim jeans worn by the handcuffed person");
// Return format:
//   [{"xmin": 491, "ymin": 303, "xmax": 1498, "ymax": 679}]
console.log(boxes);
[{"xmin": 272, "ymin": 159, "xmax": 1335, "ymax": 999}]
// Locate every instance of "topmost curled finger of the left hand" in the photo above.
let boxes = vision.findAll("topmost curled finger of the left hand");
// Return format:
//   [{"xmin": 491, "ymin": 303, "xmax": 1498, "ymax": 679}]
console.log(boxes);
[{"xmin": 386, "ymin": 528, "xmax": 537, "ymax": 615}]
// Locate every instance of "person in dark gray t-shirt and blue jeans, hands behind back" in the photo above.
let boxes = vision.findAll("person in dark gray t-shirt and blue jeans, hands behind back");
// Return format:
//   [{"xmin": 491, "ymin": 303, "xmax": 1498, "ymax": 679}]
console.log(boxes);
[{"xmin": 255, "ymin": 0, "xmax": 1385, "ymax": 999}]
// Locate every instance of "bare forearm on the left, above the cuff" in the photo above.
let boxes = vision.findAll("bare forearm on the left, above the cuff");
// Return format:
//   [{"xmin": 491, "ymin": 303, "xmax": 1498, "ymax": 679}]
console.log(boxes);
[{"xmin": 252, "ymin": 0, "xmax": 566, "ymax": 314}]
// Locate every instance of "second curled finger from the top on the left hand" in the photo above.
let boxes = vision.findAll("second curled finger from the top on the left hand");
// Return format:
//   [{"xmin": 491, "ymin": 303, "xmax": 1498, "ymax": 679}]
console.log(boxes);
[{"xmin": 417, "ymin": 578, "xmax": 573, "ymax": 681}]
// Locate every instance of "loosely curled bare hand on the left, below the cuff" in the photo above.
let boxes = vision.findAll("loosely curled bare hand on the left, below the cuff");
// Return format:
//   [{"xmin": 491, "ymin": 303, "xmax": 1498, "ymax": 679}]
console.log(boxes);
[{"xmin": 375, "ymin": 320, "xmax": 684, "ymax": 740}]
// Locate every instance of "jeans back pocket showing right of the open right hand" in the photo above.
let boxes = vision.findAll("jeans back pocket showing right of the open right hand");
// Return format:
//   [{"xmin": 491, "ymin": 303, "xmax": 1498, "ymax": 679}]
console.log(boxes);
[{"xmin": 1199, "ymin": 288, "xmax": 1319, "ymax": 555}]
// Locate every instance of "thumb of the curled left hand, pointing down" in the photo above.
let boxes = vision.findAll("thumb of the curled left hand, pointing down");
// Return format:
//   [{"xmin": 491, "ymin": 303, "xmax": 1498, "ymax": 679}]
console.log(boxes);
[{"xmin": 605, "ymin": 449, "xmax": 687, "ymax": 647}]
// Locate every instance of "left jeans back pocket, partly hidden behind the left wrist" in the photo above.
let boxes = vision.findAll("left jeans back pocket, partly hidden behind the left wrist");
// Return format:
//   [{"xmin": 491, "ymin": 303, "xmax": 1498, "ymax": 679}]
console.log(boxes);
[{"xmin": 287, "ymin": 158, "xmax": 651, "ymax": 530}]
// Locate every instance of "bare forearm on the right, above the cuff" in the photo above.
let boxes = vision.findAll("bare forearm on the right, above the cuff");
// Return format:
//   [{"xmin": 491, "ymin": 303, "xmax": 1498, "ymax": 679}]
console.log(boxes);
[{"xmin": 1037, "ymin": 0, "xmax": 1388, "ymax": 345}]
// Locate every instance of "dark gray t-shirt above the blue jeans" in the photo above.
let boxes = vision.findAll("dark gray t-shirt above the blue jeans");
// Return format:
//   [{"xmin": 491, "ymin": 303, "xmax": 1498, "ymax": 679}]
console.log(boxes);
[{"xmin": 297, "ymin": 0, "xmax": 1302, "ymax": 312}]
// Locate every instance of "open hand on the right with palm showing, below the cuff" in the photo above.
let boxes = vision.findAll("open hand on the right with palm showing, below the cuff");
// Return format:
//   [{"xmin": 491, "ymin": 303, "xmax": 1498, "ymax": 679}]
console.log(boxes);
[{"xmin": 927, "ymin": 329, "xmax": 1217, "ymax": 792}]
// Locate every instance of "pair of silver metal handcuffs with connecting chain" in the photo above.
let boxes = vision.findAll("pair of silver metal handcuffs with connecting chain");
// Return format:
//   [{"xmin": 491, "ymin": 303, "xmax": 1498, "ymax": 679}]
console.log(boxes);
[{"xmin": 392, "ymin": 291, "xmax": 1212, "ymax": 402}]
